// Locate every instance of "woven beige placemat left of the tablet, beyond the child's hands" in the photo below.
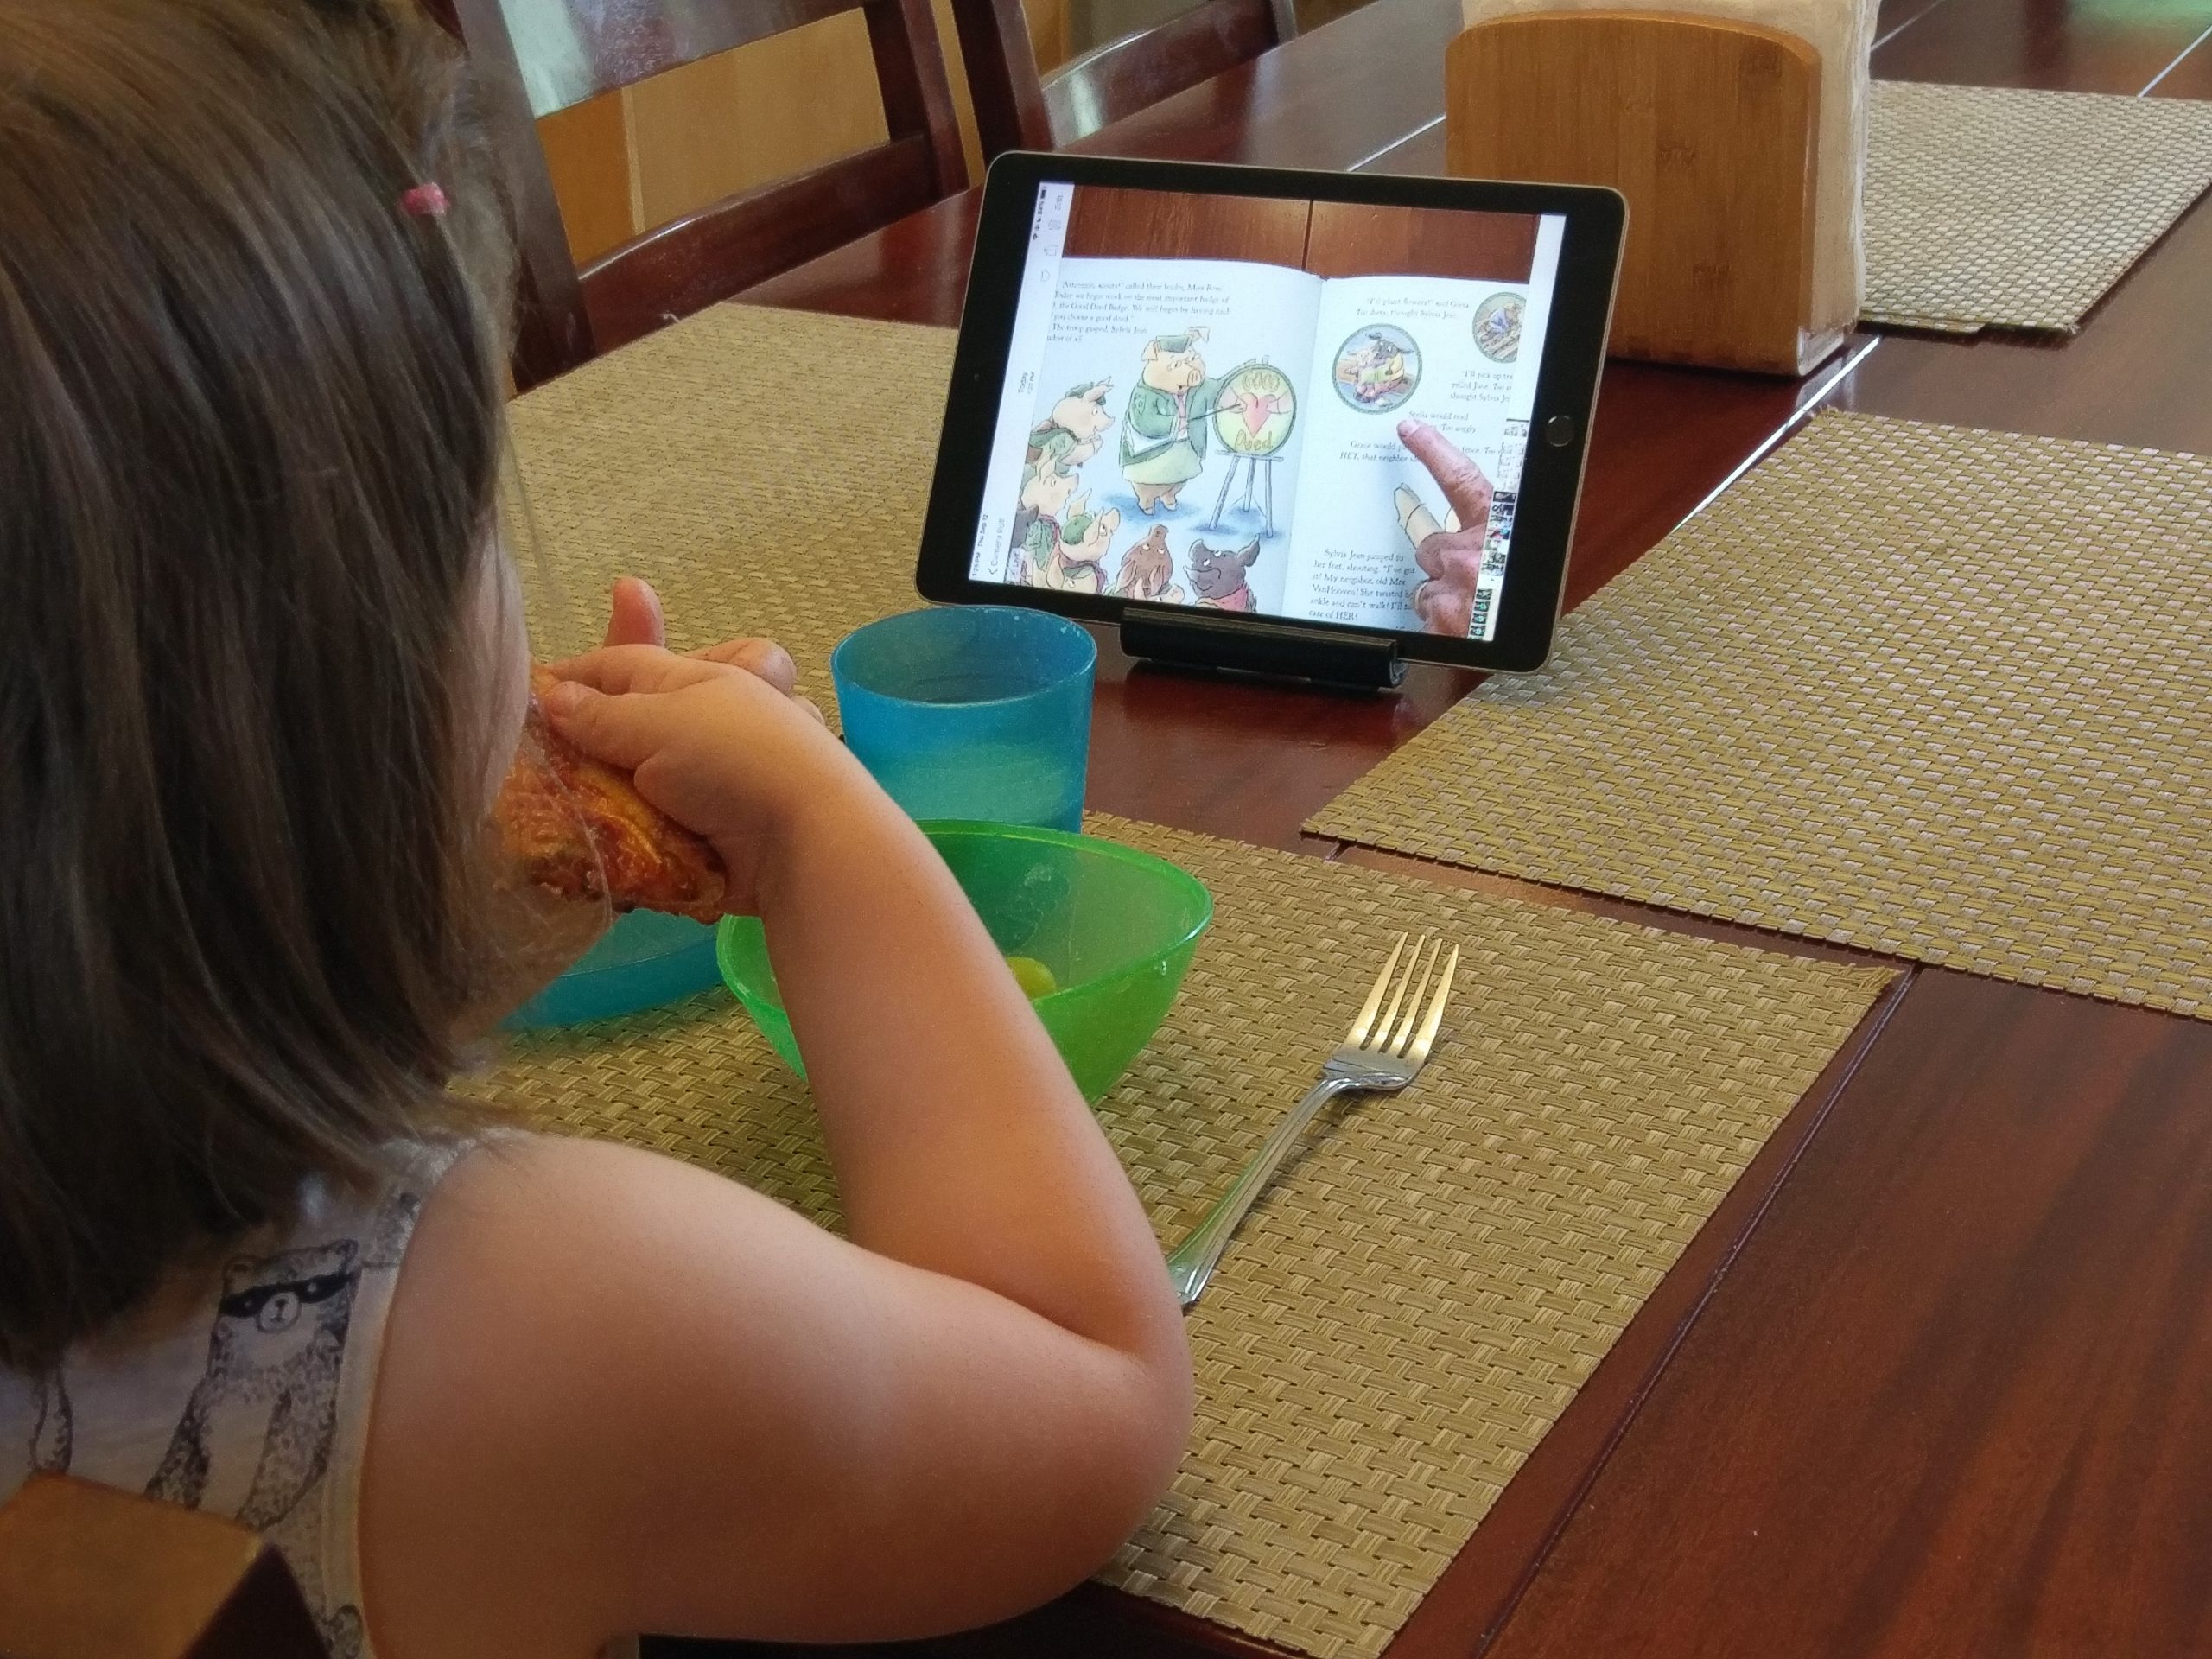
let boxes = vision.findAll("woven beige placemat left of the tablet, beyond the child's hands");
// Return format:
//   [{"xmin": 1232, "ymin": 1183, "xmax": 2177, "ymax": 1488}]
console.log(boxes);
[{"xmin": 506, "ymin": 305, "xmax": 953, "ymax": 694}]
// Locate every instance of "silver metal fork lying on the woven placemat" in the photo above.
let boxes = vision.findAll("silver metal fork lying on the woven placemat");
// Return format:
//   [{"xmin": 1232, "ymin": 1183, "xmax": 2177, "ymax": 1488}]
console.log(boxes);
[{"xmin": 1168, "ymin": 933, "xmax": 1460, "ymax": 1307}]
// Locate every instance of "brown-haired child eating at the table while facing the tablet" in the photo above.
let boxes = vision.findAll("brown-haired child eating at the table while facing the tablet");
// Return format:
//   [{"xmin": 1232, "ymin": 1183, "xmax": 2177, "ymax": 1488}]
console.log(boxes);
[{"xmin": 0, "ymin": 0, "xmax": 1190, "ymax": 1659}]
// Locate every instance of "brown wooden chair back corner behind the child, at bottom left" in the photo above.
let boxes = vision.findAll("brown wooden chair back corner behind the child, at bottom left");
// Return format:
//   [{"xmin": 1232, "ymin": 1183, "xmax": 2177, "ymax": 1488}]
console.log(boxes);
[{"xmin": 0, "ymin": 1476, "xmax": 325, "ymax": 1659}]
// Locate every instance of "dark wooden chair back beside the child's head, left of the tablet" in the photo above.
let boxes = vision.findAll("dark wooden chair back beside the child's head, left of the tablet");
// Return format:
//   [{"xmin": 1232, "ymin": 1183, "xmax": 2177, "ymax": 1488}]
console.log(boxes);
[{"xmin": 423, "ymin": 0, "xmax": 969, "ymax": 390}]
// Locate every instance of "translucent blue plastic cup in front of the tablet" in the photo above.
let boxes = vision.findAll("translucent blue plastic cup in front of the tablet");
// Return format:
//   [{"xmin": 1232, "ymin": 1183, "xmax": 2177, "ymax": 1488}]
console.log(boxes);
[{"xmin": 830, "ymin": 604, "xmax": 1099, "ymax": 830}]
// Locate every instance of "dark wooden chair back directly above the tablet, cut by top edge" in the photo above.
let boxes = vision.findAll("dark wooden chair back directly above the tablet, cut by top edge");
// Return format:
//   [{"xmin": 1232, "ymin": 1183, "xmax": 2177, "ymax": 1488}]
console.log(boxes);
[{"xmin": 951, "ymin": 0, "xmax": 1299, "ymax": 162}]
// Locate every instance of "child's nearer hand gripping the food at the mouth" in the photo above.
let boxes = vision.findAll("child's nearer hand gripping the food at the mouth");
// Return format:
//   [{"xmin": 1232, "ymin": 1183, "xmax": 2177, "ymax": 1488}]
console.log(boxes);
[{"xmin": 542, "ymin": 639, "xmax": 876, "ymax": 912}]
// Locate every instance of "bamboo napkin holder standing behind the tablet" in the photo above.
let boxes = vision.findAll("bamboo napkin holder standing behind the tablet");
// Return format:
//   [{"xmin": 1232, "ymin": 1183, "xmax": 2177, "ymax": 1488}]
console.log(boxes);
[{"xmin": 1445, "ymin": 11, "xmax": 1845, "ymax": 374}]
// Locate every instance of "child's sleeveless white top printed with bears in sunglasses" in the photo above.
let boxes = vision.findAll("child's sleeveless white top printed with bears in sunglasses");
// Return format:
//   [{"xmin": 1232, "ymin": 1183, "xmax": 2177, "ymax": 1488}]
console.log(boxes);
[{"xmin": 0, "ymin": 1148, "xmax": 462, "ymax": 1659}]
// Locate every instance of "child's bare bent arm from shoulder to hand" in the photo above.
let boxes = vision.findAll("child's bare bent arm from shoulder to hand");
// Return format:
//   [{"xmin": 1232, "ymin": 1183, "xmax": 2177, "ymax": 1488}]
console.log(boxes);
[{"xmin": 363, "ymin": 651, "xmax": 1190, "ymax": 1659}]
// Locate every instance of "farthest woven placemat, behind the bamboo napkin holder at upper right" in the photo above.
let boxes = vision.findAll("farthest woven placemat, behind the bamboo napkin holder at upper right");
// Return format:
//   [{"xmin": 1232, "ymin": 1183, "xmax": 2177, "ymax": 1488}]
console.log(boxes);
[{"xmin": 1860, "ymin": 79, "xmax": 2212, "ymax": 334}]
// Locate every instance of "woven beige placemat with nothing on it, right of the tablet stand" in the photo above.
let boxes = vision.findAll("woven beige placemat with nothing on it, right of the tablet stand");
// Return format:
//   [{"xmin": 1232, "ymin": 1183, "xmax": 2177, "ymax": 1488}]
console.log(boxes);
[{"xmin": 1307, "ymin": 414, "xmax": 2212, "ymax": 1018}]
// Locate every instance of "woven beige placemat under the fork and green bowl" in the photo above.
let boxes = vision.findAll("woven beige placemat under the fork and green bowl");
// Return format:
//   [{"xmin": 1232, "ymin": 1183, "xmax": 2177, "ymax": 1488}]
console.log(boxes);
[{"xmin": 462, "ymin": 818, "xmax": 1889, "ymax": 1659}]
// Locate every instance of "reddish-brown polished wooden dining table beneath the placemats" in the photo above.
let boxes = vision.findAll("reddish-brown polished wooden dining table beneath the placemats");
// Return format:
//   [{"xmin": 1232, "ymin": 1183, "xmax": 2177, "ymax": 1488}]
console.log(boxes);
[{"xmin": 698, "ymin": 0, "xmax": 2212, "ymax": 1659}]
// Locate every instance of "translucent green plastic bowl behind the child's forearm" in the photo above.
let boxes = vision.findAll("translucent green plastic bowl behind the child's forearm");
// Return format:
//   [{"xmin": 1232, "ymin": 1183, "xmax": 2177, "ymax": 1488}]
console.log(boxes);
[{"xmin": 715, "ymin": 823, "xmax": 1214, "ymax": 1103}]
